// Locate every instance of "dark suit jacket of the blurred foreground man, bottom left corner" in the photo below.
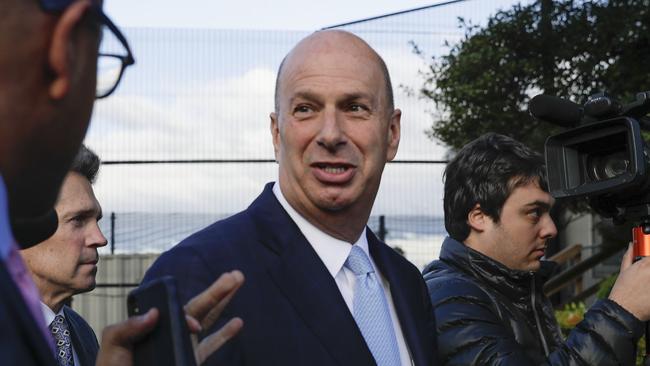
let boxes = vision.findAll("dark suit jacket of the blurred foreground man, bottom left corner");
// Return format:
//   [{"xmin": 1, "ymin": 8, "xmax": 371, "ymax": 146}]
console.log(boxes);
[{"xmin": 0, "ymin": 260, "xmax": 56, "ymax": 366}]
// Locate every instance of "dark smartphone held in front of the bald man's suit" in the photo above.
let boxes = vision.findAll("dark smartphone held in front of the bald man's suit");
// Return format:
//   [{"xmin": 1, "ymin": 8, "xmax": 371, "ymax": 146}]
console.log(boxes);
[{"xmin": 127, "ymin": 276, "xmax": 196, "ymax": 366}]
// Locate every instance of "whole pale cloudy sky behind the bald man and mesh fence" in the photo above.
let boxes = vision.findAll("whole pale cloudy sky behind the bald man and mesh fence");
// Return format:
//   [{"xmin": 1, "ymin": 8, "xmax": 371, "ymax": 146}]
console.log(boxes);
[{"xmin": 86, "ymin": 0, "xmax": 532, "ymax": 216}]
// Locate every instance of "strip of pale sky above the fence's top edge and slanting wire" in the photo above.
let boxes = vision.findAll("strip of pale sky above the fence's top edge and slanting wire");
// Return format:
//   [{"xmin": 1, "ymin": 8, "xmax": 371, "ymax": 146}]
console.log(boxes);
[{"xmin": 105, "ymin": 0, "xmax": 460, "ymax": 31}]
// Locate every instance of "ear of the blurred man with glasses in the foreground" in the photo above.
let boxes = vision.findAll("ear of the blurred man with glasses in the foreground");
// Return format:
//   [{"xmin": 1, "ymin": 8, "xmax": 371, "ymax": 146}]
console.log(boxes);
[{"xmin": 48, "ymin": 0, "xmax": 90, "ymax": 100}]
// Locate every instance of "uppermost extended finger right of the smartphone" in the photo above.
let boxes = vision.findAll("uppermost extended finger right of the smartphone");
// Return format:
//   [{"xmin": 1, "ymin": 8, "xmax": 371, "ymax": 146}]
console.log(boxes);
[{"xmin": 185, "ymin": 271, "xmax": 244, "ymax": 328}]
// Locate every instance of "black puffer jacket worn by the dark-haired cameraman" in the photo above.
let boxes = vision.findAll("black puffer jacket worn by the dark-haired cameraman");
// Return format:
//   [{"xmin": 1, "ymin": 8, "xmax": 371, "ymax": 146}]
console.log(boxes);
[{"xmin": 424, "ymin": 238, "xmax": 643, "ymax": 366}]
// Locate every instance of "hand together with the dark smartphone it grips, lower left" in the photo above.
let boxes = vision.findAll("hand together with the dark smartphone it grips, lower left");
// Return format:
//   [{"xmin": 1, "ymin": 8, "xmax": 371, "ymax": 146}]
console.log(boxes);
[{"xmin": 118, "ymin": 270, "xmax": 244, "ymax": 366}]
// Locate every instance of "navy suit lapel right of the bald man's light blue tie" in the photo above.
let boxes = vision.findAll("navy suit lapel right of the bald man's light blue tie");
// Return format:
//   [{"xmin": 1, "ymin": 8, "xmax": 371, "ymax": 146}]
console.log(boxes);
[{"xmin": 367, "ymin": 230, "xmax": 433, "ymax": 365}]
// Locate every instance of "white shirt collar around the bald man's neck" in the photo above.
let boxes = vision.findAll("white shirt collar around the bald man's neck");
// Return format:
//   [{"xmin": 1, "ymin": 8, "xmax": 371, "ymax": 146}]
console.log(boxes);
[{"xmin": 273, "ymin": 182, "xmax": 370, "ymax": 277}]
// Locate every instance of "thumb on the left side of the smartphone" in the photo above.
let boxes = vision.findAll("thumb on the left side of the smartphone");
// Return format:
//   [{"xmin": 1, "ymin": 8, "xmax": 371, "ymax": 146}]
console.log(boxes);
[{"xmin": 102, "ymin": 309, "xmax": 158, "ymax": 348}]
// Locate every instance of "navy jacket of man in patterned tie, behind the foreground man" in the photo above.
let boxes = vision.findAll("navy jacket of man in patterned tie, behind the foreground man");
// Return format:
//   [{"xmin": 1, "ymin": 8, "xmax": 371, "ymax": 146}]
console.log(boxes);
[{"xmin": 63, "ymin": 305, "xmax": 99, "ymax": 366}]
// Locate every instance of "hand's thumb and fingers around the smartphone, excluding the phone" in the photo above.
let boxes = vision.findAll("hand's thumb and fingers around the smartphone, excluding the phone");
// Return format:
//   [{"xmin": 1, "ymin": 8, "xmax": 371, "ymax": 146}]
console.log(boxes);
[{"xmin": 96, "ymin": 271, "xmax": 244, "ymax": 366}]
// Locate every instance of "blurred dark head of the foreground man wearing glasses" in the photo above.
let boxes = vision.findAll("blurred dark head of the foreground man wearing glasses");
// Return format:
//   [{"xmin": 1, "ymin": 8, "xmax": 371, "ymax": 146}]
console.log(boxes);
[{"xmin": 0, "ymin": 0, "xmax": 132, "ymax": 248}]
